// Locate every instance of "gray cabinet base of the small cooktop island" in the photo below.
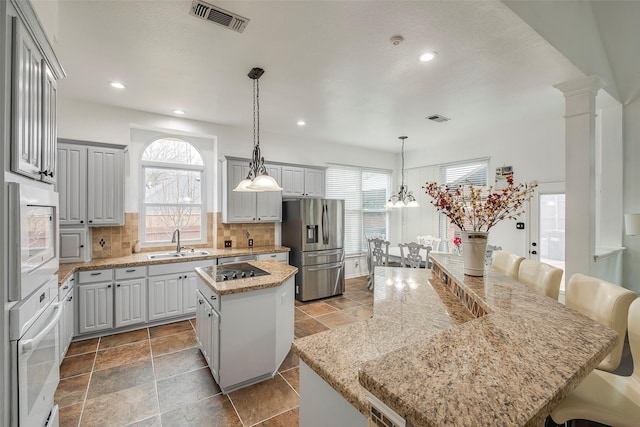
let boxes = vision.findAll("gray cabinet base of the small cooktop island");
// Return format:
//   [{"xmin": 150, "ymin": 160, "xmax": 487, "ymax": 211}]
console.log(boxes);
[{"xmin": 196, "ymin": 277, "xmax": 295, "ymax": 393}]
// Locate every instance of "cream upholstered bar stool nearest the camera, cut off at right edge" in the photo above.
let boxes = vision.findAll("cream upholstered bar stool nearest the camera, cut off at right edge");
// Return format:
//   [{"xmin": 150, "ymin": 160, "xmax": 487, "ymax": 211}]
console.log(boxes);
[{"xmin": 551, "ymin": 299, "xmax": 640, "ymax": 427}]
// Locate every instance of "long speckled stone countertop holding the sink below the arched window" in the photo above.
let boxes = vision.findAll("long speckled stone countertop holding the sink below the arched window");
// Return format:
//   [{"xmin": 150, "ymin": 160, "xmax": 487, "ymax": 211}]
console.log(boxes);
[{"xmin": 58, "ymin": 246, "xmax": 289, "ymax": 284}]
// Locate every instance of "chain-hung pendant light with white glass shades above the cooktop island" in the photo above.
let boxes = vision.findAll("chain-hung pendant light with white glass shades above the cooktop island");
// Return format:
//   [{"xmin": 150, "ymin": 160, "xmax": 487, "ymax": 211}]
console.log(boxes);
[{"xmin": 233, "ymin": 68, "xmax": 282, "ymax": 191}]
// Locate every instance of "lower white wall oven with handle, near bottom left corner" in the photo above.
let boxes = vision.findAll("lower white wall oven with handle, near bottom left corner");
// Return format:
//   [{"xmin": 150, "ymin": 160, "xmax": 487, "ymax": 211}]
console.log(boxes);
[{"xmin": 9, "ymin": 276, "xmax": 62, "ymax": 427}]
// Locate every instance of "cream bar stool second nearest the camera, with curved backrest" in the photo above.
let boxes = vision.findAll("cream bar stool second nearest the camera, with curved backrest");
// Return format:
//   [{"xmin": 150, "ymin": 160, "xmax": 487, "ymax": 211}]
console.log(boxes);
[{"xmin": 565, "ymin": 273, "xmax": 640, "ymax": 372}]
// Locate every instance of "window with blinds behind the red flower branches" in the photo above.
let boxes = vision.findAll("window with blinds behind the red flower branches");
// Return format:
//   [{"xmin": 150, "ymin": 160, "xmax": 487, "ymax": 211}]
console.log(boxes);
[{"xmin": 440, "ymin": 159, "xmax": 489, "ymax": 242}]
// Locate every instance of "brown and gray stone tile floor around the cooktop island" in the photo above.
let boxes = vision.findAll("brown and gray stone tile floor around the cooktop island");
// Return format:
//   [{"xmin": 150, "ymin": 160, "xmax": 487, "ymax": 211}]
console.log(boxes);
[{"xmin": 55, "ymin": 277, "xmax": 373, "ymax": 427}]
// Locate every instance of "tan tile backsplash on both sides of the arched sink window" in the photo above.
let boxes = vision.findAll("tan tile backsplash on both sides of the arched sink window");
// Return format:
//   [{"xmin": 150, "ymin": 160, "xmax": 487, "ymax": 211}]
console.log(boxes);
[{"xmin": 90, "ymin": 212, "xmax": 275, "ymax": 258}]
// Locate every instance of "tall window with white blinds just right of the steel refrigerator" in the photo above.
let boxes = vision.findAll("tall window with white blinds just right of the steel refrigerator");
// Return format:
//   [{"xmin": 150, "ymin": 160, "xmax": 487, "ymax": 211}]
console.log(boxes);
[{"xmin": 326, "ymin": 166, "xmax": 391, "ymax": 255}]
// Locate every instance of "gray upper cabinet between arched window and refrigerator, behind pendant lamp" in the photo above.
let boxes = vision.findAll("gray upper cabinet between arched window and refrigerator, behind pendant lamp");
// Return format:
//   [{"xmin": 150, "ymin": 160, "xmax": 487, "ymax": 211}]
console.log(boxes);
[{"xmin": 220, "ymin": 157, "xmax": 282, "ymax": 224}]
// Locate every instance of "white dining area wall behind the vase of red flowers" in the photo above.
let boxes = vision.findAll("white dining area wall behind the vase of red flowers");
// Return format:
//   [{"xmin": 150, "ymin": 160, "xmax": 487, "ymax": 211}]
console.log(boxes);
[{"xmin": 392, "ymin": 116, "xmax": 565, "ymax": 256}]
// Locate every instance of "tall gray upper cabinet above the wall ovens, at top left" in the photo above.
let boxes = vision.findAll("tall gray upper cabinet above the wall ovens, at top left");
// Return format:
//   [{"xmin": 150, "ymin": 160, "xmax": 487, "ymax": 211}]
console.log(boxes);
[{"xmin": 8, "ymin": 2, "xmax": 64, "ymax": 183}]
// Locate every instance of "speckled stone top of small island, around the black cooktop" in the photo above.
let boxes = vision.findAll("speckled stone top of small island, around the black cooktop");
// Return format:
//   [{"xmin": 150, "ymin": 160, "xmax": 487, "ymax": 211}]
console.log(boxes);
[{"xmin": 196, "ymin": 261, "xmax": 298, "ymax": 295}]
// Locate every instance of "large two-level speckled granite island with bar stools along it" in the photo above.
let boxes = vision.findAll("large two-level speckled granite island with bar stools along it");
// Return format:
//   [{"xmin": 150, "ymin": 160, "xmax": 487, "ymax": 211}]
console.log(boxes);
[{"xmin": 292, "ymin": 254, "xmax": 617, "ymax": 427}]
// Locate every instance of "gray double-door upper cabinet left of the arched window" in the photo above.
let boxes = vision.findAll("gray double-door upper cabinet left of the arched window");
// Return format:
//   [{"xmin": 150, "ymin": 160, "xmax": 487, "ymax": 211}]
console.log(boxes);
[{"xmin": 56, "ymin": 139, "xmax": 125, "ymax": 227}]
